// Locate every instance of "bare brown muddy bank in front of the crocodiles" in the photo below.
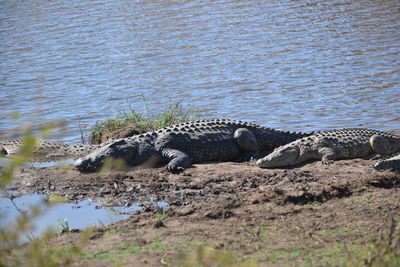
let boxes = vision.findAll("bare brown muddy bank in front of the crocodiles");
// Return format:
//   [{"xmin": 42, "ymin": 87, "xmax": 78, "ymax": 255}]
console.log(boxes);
[{"xmin": 6, "ymin": 159, "xmax": 400, "ymax": 266}]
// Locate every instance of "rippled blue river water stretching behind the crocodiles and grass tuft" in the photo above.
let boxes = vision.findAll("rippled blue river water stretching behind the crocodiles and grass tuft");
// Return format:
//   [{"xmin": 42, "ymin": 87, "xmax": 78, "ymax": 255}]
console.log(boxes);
[{"xmin": 0, "ymin": 0, "xmax": 400, "ymax": 143}]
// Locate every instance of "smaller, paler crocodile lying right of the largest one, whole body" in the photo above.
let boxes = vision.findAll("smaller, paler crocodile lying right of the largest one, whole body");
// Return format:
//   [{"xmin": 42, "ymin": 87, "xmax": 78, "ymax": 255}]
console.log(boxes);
[{"xmin": 256, "ymin": 128, "xmax": 400, "ymax": 168}]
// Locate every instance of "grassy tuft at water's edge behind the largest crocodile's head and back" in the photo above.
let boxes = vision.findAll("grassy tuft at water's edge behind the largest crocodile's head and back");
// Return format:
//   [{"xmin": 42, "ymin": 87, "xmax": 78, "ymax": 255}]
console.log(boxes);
[{"xmin": 90, "ymin": 95, "xmax": 202, "ymax": 144}]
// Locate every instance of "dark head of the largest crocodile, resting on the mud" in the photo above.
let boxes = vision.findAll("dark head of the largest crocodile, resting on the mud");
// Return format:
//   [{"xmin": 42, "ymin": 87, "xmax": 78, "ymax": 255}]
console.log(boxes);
[{"xmin": 75, "ymin": 139, "xmax": 138, "ymax": 172}]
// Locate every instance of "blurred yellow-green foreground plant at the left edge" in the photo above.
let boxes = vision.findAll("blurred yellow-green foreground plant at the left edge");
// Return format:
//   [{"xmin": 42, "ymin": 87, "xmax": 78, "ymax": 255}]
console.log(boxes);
[{"xmin": 0, "ymin": 128, "xmax": 80, "ymax": 267}]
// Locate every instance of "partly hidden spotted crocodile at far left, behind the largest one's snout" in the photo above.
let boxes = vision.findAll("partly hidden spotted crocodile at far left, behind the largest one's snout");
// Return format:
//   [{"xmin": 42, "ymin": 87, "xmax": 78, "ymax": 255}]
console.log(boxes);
[{"xmin": 0, "ymin": 140, "xmax": 100, "ymax": 159}]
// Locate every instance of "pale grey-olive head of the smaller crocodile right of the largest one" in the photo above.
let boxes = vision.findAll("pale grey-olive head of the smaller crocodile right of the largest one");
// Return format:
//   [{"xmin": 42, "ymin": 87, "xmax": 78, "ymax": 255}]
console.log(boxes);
[{"xmin": 256, "ymin": 146, "xmax": 300, "ymax": 168}]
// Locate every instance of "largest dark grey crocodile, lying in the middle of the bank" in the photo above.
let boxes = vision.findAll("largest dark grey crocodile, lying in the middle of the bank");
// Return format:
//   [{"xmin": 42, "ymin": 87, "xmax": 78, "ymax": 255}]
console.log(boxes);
[{"xmin": 75, "ymin": 119, "xmax": 310, "ymax": 172}]
